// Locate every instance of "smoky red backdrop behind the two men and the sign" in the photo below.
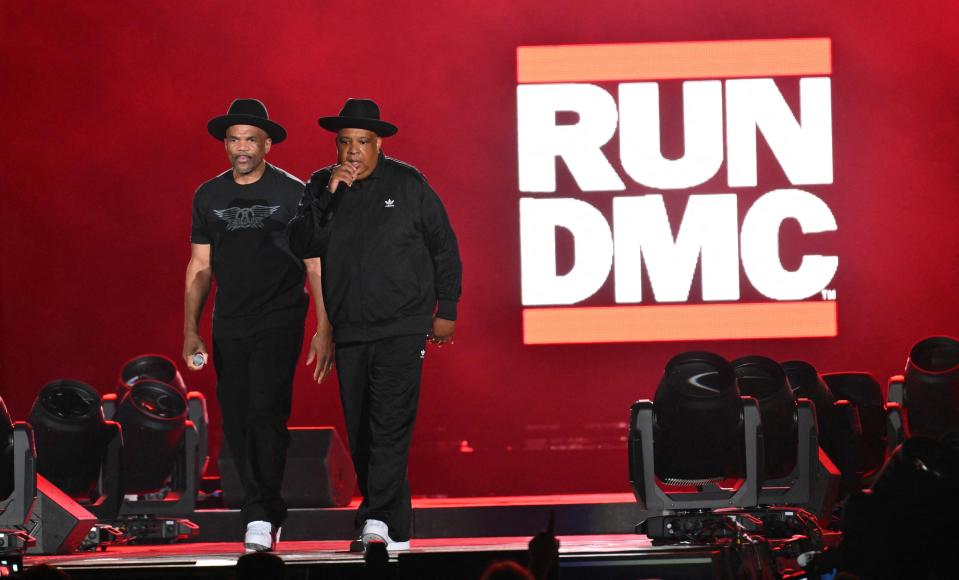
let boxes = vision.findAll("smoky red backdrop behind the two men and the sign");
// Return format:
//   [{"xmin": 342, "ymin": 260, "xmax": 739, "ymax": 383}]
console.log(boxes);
[{"xmin": 0, "ymin": 0, "xmax": 959, "ymax": 495}]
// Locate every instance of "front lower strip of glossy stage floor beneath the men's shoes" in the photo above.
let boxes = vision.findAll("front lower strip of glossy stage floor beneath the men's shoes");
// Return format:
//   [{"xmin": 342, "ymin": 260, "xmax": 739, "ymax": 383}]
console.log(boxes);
[{"xmin": 31, "ymin": 534, "xmax": 736, "ymax": 579}]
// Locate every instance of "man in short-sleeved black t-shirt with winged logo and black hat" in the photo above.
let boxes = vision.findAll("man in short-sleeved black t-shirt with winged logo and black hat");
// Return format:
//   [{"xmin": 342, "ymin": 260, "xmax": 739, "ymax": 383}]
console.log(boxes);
[{"xmin": 183, "ymin": 99, "xmax": 312, "ymax": 551}]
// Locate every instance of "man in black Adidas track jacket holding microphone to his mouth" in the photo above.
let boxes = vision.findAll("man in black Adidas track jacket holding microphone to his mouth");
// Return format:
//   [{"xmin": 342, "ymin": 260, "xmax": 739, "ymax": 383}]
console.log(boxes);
[{"xmin": 290, "ymin": 99, "xmax": 462, "ymax": 551}]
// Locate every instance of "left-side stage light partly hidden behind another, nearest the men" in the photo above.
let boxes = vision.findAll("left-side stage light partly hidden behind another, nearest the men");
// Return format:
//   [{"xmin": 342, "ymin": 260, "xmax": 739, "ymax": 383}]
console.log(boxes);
[{"xmin": 117, "ymin": 354, "xmax": 210, "ymax": 477}]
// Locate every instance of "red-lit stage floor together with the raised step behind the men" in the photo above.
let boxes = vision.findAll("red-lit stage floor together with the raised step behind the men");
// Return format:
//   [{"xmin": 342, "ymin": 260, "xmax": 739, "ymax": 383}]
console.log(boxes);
[{"xmin": 24, "ymin": 493, "xmax": 744, "ymax": 580}]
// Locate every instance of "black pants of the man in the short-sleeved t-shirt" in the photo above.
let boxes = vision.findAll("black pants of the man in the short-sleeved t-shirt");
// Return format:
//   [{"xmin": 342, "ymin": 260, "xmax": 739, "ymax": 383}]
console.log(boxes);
[{"xmin": 213, "ymin": 326, "xmax": 303, "ymax": 526}]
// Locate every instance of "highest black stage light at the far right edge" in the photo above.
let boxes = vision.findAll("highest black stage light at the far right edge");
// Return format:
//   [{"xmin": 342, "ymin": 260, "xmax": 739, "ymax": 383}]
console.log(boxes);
[{"xmin": 888, "ymin": 336, "xmax": 959, "ymax": 446}]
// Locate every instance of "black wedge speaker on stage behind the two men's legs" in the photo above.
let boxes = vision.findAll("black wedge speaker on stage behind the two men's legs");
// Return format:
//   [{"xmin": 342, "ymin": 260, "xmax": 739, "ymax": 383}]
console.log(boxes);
[{"xmin": 219, "ymin": 427, "xmax": 356, "ymax": 508}]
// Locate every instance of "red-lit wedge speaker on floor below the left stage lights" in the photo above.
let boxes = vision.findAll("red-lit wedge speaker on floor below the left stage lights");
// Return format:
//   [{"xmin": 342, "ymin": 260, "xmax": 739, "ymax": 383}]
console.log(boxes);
[{"xmin": 26, "ymin": 474, "xmax": 97, "ymax": 554}]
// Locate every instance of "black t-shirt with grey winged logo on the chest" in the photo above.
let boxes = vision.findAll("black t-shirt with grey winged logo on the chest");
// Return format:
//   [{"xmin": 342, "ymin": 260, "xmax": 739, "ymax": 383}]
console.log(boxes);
[{"xmin": 190, "ymin": 164, "xmax": 309, "ymax": 338}]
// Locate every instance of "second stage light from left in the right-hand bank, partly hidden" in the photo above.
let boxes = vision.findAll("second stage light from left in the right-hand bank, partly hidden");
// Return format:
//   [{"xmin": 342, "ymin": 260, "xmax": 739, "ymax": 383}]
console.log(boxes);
[{"xmin": 732, "ymin": 356, "xmax": 840, "ymax": 524}]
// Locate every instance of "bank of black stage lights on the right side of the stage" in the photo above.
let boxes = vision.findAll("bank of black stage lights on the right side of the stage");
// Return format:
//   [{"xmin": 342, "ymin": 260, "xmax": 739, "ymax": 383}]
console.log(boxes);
[{"xmin": 628, "ymin": 337, "xmax": 959, "ymax": 578}]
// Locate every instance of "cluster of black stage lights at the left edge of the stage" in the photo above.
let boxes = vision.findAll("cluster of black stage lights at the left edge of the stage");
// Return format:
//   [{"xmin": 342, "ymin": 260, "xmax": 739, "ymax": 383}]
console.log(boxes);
[{"xmin": 0, "ymin": 355, "xmax": 208, "ymax": 553}]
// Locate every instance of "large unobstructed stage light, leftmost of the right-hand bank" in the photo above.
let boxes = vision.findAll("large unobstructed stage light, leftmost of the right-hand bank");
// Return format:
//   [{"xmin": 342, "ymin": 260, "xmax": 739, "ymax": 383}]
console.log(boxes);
[{"xmin": 629, "ymin": 352, "xmax": 762, "ymax": 512}]
